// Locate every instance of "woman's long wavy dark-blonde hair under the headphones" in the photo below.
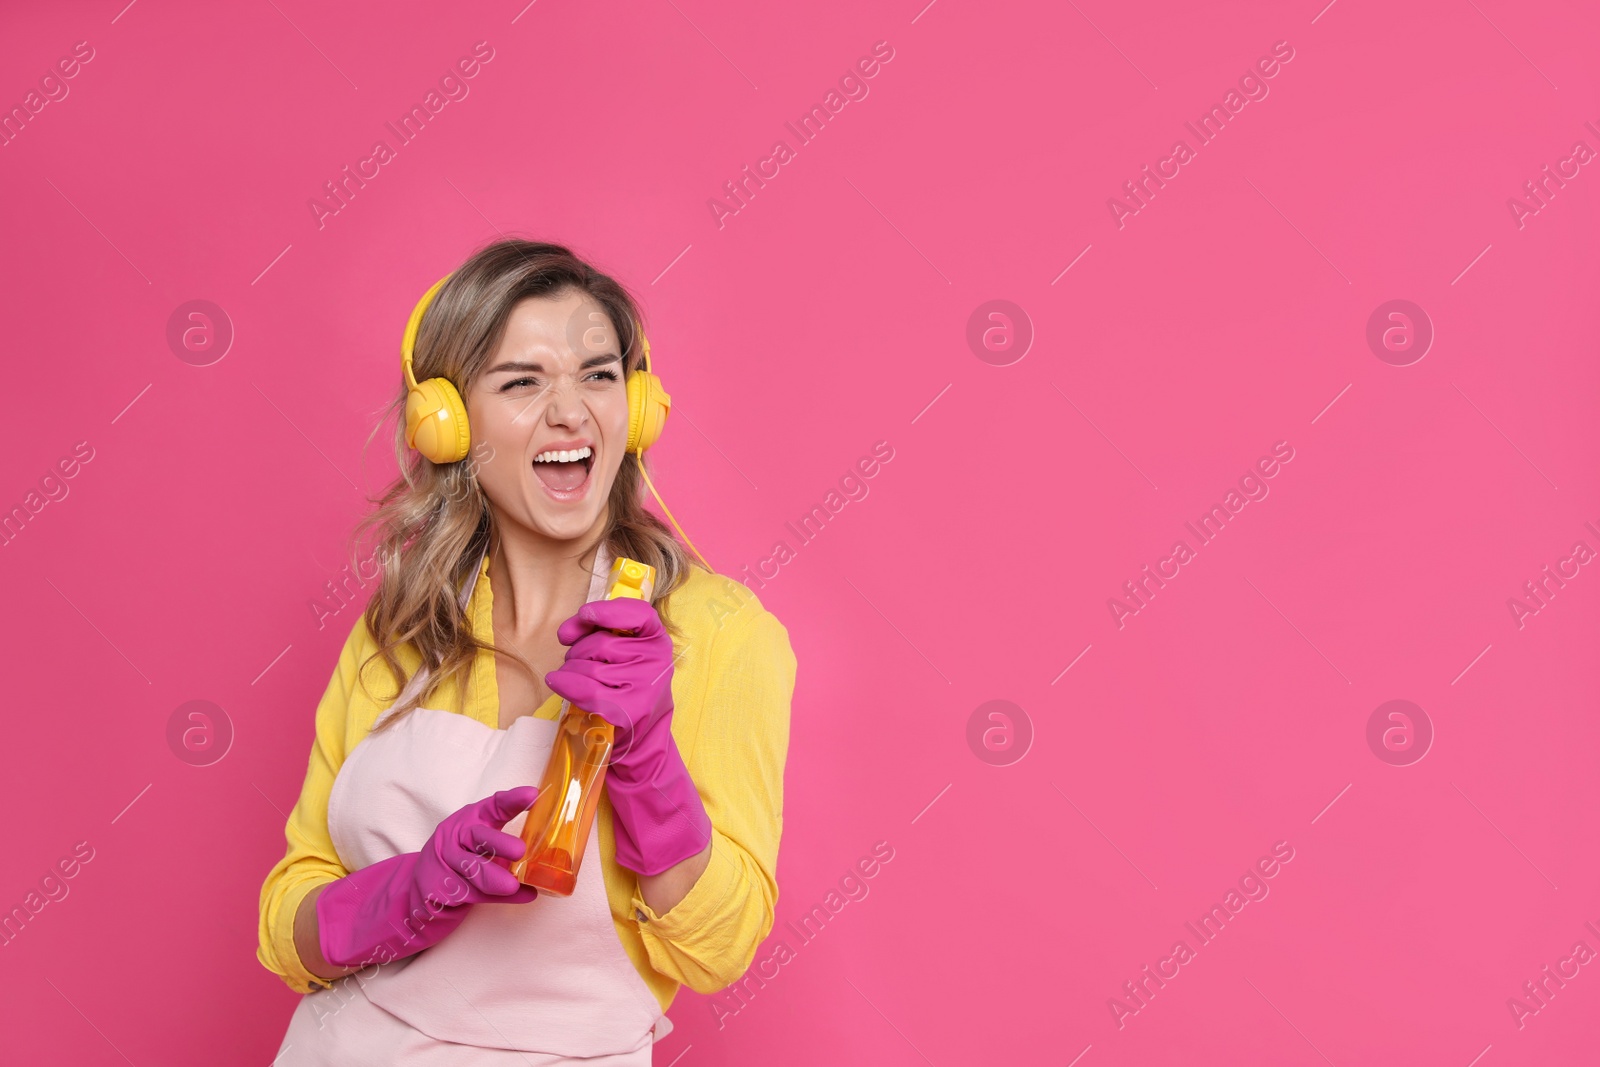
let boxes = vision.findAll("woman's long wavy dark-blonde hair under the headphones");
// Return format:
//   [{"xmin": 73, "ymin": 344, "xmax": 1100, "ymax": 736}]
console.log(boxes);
[{"xmin": 352, "ymin": 238, "xmax": 704, "ymax": 729}]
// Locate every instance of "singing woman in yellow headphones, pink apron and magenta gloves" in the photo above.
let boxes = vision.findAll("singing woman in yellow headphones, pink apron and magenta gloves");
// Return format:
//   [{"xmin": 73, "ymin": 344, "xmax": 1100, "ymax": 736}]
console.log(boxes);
[{"xmin": 258, "ymin": 240, "xmax": 795, "ymax": 1067}]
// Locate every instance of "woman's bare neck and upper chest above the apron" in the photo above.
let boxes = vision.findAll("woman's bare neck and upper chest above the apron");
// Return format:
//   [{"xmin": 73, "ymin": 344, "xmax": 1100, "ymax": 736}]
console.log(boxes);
[{"xmin": 488, "ymin": 515, "xmax": 605, "ymax": 640}]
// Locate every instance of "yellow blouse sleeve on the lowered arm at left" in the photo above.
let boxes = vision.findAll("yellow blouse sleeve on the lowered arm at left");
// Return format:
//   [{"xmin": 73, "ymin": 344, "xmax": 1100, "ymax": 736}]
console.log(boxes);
[{"xmin": 256, "ymin": 617, "xmax": 376, "ymax": 993}]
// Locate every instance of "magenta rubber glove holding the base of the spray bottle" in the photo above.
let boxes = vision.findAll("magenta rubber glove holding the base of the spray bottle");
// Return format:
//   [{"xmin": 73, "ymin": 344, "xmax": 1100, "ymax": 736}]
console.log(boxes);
[{"xmin": 317, "ymin": 785, "xmax": 539, "ymax": 968}]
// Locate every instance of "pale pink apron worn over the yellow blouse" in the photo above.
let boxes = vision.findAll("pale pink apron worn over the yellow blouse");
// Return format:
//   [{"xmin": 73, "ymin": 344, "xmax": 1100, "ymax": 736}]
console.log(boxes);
[{"xmin": 274, "ymin": 545, "xmax": 672, "ymax": 1067}]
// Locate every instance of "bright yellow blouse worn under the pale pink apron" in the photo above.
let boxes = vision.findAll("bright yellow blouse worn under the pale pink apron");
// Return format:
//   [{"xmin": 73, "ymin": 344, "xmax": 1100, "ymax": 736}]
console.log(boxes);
[{"xmin": 256, "ymin": 558, "xmax": 795, "ymax": 1011}]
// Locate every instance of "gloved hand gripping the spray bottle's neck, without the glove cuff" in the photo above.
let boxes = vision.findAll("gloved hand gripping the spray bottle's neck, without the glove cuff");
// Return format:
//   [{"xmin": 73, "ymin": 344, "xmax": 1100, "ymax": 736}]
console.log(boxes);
[{"xmin": 544, "ymin": 597, "xmax": 672, "ymax": 766}]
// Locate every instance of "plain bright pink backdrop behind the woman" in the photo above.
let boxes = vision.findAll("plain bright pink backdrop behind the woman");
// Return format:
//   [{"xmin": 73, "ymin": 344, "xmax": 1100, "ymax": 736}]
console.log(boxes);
[{"xmin": 0, "ymin": 0, "xmax": 1600, "ymax": 1067}]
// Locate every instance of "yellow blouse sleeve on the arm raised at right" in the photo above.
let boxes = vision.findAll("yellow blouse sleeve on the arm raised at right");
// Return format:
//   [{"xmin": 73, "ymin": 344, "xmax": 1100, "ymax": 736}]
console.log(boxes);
[{"xmin": 632, "ymin": 609, "xmax": 795, "ymax": 993}]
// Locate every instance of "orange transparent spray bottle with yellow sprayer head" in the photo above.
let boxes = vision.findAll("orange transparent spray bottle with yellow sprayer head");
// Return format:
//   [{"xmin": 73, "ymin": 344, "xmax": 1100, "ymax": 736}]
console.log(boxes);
[{"xmin": 510, "ymin": 557, "xmax": 656, "ymax": 896}]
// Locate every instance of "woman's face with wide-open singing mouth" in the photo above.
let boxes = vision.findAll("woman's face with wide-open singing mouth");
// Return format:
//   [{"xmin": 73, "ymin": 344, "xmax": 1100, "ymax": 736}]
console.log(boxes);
[{"xmin": 466, "ymin": 290, "xmax": 627, "ymax": 541}]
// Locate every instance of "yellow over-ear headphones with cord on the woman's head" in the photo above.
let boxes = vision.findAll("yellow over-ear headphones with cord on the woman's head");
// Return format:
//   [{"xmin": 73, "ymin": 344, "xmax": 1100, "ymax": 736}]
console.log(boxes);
[{"xmin": 400, "ymin": 274, "xmax": 712, "ymax": 569}]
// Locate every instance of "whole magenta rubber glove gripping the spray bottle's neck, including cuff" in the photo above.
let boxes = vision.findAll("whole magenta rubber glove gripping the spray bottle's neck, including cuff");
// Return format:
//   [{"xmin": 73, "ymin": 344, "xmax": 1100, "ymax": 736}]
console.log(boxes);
[{"xmin": 544, "ymin": 598, "xmax": 710, "ymax": 875}]
